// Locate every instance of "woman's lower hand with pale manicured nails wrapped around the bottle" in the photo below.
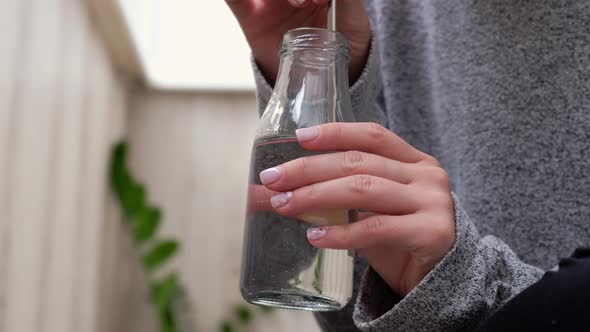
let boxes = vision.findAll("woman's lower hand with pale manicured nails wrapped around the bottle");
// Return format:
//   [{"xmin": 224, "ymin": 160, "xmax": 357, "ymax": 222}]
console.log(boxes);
[{"xmin": 260, "ymin": 123, "xmax": 455, "ymax": 296}]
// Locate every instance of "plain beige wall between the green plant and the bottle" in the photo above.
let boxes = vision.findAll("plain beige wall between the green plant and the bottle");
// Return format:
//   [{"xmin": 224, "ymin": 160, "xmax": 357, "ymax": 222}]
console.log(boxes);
[{"xmin": 128, "ymin": 92, "xmax": 318, "ymax": 332}]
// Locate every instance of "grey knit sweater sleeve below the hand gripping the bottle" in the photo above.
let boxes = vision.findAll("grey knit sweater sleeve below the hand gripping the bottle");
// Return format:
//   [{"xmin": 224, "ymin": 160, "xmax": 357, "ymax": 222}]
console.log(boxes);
[{"xmin": 353, "ymin": 197, "xmax": 543, "ymax": 332}]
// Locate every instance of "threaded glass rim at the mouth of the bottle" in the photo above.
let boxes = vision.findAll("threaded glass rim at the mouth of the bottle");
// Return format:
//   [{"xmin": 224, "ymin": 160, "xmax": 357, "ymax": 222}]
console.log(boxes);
[{"xmin": 281, "ymin": 28, "xmax": 350, "ymax": 59}]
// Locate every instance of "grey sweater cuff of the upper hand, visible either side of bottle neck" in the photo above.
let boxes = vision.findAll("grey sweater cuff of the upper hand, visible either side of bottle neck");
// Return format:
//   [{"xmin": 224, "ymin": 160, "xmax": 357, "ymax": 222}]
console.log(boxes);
[{"xmin": 251, "ymin": 40, "xmax": 387, "ymax": 126}]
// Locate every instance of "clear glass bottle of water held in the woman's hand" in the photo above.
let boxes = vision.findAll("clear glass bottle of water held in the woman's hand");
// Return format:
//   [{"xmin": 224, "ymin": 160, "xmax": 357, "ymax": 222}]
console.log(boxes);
[{"xmin": 240, "ymin": 28, "xmax": 354, "ymax": 311}]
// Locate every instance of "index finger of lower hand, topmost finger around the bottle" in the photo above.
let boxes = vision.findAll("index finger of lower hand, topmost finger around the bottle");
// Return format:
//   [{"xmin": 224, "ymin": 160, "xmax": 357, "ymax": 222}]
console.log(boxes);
[{"xmin": 296, "ymin": 122, "xmax": 434, "ymax": 163}]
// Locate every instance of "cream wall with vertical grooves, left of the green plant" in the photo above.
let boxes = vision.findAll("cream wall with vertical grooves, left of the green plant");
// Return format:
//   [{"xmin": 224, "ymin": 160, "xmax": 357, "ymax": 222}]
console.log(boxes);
[{"xmin": 0, "ymin": 0, "xmax": 131, "ymax": 332}]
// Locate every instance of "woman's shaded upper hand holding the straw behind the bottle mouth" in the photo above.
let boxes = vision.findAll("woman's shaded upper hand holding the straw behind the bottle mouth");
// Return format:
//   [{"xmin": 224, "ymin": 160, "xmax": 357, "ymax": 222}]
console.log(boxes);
[{"xmin": 226, "ymin": 0, "xmax": 371, "ymax": 82}]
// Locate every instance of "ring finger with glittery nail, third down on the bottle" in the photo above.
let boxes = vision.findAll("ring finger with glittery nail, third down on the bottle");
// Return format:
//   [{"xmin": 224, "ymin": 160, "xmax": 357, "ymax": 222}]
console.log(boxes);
[{"xmin": 270, "ymin": 175, "xmax": 424, "ymax": 217}]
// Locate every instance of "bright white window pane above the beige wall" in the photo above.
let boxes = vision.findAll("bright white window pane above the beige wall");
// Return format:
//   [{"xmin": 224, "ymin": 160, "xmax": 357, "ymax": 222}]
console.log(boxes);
[{"xmin": 118, "ymin": 0, "xmax": 254, "ymax": 91}]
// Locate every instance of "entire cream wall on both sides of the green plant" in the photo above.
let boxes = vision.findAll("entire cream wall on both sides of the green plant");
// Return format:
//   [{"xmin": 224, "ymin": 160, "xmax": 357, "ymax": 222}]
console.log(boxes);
[{"xmin": 0, "ymin": 0, "xmax": 324, "ymax": 332}]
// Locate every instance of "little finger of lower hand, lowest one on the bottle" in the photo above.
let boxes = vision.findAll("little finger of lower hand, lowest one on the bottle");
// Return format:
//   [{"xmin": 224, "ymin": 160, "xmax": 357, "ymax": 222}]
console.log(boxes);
[{"xmin": 307, "ymin": 214, "xmax": 423, "ymax": 249}]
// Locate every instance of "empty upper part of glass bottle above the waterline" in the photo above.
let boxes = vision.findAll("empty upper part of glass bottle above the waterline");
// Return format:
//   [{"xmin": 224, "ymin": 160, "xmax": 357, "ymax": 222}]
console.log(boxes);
[{"xmin": 256, "ymin": 28, "xmax": 354, "ymax": 141}]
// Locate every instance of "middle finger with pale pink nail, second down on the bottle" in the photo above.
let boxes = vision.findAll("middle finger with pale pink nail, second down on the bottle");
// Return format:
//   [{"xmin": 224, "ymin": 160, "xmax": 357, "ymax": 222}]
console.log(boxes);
[{"xmin": 260, "ymin": 151, "xmax": 423, "ymax": 192}]
